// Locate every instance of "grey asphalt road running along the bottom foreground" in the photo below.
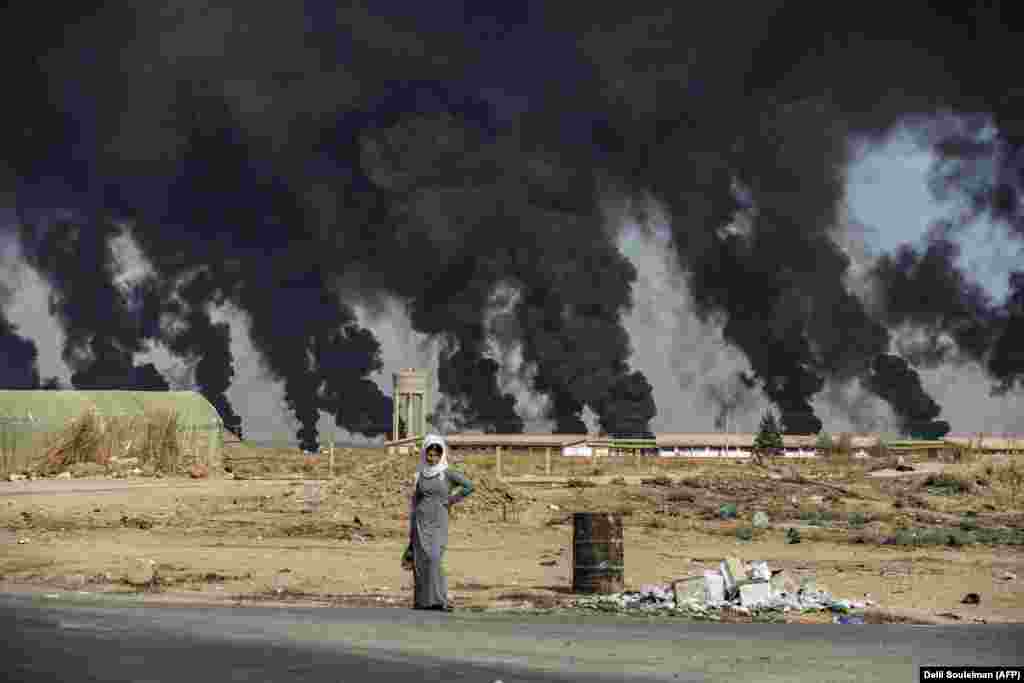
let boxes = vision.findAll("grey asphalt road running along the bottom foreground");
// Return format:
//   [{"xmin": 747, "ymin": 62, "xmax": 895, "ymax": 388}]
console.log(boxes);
[{"xmin": 6, "ymin": 594, "xmax": 1024, "ymax": 683}]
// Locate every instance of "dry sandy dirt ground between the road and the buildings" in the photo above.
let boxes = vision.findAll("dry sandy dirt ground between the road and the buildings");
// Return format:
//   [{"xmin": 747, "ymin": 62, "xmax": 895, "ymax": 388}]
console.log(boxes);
[{"xmin": 0, "ymin": 448, "xmax": 1024, "ymax": 623}]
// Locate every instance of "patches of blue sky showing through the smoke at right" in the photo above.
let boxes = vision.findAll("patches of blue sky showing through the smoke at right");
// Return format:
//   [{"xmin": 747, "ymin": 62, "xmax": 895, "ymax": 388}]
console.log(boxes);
[{"xmin": 847, "ymin": 126, "xmax": 1024, "ymax": 302}]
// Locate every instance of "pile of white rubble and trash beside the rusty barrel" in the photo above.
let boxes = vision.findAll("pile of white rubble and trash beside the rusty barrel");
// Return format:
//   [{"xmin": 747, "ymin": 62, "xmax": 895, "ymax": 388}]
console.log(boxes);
[{"xmin": 575, "ymin": 557, "xmax": 876, "ymax": 624}]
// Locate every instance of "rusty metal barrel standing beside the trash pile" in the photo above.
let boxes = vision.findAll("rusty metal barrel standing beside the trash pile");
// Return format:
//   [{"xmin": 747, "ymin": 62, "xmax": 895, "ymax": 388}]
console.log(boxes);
[{"xmin": 572, "ymin": 512, "xmax": 625, "ymax": 594}]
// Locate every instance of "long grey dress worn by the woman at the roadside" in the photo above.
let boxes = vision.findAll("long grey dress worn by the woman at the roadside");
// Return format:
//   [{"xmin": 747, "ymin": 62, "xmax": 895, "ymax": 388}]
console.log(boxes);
[{"xmin": 411, "ymin": 469, "xmax": 473, "ymax": 607}]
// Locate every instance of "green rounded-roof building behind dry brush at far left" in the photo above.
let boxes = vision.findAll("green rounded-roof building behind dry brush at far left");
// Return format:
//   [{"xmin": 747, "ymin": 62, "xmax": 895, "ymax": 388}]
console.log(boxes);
[{"xmin": 0, "ymin": 390, "xmax": 223, "ymax": 469}]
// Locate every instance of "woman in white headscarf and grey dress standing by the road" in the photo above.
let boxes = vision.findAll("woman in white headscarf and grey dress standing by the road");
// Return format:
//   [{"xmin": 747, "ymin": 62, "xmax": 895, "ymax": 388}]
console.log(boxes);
[{"xmin": 406, "ymin": 434, "xmax": 473, "ymax": 611}]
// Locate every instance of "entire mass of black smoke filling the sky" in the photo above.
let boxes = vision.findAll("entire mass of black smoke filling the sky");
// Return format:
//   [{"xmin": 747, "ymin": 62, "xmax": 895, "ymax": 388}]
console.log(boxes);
[{"xmin": 0, "ymin": 0, "xmax": 1024, "ymax": 447}]
